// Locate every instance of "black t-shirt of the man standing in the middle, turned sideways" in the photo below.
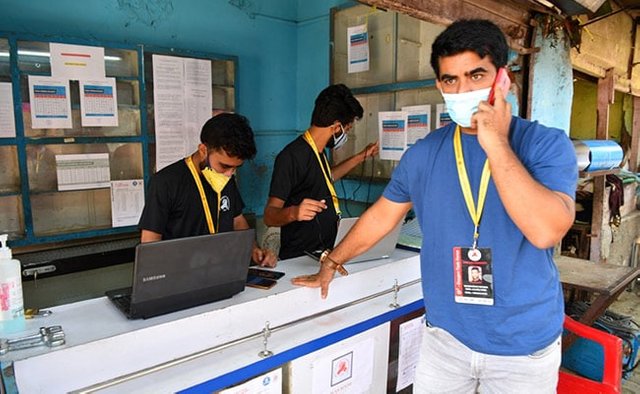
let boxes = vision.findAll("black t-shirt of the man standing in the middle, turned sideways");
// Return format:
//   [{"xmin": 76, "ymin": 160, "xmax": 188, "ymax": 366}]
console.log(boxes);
[{"xmin": 269, "ymin": 137, "xmax": 338, "ymax": 259}]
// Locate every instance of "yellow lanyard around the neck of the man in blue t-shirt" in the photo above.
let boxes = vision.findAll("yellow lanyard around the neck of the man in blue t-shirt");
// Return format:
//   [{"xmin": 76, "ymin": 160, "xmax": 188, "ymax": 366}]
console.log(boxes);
[{"xmin": 453, "ymin": 126, "xmax": 491, "ymax": 249}]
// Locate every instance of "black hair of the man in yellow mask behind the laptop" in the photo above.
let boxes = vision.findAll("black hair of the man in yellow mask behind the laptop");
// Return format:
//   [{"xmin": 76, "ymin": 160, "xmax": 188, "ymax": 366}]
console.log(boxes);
[{"xmin": 200, "ymin": 113, "xmax": 257, "ymax": 160}]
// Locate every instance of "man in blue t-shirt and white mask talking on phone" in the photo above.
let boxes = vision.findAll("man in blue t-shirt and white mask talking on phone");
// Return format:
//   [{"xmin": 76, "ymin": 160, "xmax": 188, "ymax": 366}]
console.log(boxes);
[{"xmin": 294, "ymin": 20, "xmax": 577, "ymax": 393}]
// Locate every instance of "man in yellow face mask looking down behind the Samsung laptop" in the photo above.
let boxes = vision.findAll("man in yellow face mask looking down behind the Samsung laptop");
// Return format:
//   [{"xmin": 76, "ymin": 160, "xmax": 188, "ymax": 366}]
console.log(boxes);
[{"xmin": 139, "ymin": 113, "xmax": 277, "ymax": 267}]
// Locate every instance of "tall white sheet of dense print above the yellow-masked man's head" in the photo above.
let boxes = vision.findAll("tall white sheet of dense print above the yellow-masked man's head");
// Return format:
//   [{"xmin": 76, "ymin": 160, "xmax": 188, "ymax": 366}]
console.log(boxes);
[{"xmin": 152, "ymin": 55, "xmax": 213, "ymax": 171}]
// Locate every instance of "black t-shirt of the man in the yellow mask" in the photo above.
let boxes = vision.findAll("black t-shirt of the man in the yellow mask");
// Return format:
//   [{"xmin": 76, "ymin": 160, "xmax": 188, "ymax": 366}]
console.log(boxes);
[{"xmin": 138, "ymin": 159, "xmax": 244, "ymax": 239}]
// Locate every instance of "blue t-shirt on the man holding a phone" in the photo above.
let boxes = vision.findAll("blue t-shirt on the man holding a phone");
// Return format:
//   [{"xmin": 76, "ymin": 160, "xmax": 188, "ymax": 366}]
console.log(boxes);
[{"xmin": 384, "ymin": 117, "xmax": 578, "ymax": 355}]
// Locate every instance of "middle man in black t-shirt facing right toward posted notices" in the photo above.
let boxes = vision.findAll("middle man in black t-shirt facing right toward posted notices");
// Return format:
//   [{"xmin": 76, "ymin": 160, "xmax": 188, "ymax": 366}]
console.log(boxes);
[{"xmin": 264, "ymin": 84, "xmax": 378, "ymax": 259}]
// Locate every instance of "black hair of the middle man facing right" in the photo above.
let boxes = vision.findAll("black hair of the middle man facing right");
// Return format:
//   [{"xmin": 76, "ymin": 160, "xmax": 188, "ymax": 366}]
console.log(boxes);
[{"xmin": 311, "ymin": 84, "xmax": 364, "ymax": 127}]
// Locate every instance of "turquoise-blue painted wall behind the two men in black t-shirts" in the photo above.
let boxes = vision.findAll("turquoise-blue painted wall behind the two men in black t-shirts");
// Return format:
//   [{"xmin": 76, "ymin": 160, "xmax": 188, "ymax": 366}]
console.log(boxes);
[{"xmin": 0, "ymin": 0, "xmax": 310, "ymax": 215}]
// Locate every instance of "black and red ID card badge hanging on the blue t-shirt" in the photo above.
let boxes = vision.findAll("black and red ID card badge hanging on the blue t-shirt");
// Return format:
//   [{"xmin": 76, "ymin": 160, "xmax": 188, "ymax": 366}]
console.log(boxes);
[{"xmin": 453, "ymin": 246, "xmax": 494, "ymax": 305}]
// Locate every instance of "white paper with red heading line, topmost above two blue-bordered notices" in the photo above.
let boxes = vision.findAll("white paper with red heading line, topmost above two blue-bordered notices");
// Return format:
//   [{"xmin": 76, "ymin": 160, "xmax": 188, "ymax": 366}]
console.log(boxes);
[{"xmin": 49, "ymin": 42, "xmax": 105, "ymax": 80}]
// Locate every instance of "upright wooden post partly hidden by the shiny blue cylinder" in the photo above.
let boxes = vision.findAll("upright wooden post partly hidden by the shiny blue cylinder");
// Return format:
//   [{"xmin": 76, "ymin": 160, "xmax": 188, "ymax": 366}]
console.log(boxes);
[{"xmin": 589, "ymin": 68, "xmax": 615, "ymax": 261}]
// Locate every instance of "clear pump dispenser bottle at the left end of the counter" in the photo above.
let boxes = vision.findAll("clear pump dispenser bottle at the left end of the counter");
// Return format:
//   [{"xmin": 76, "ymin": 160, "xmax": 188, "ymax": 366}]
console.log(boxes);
[{"xmin": 0, "ymin": 234, "xmax": 25, "ymax": 337}]
